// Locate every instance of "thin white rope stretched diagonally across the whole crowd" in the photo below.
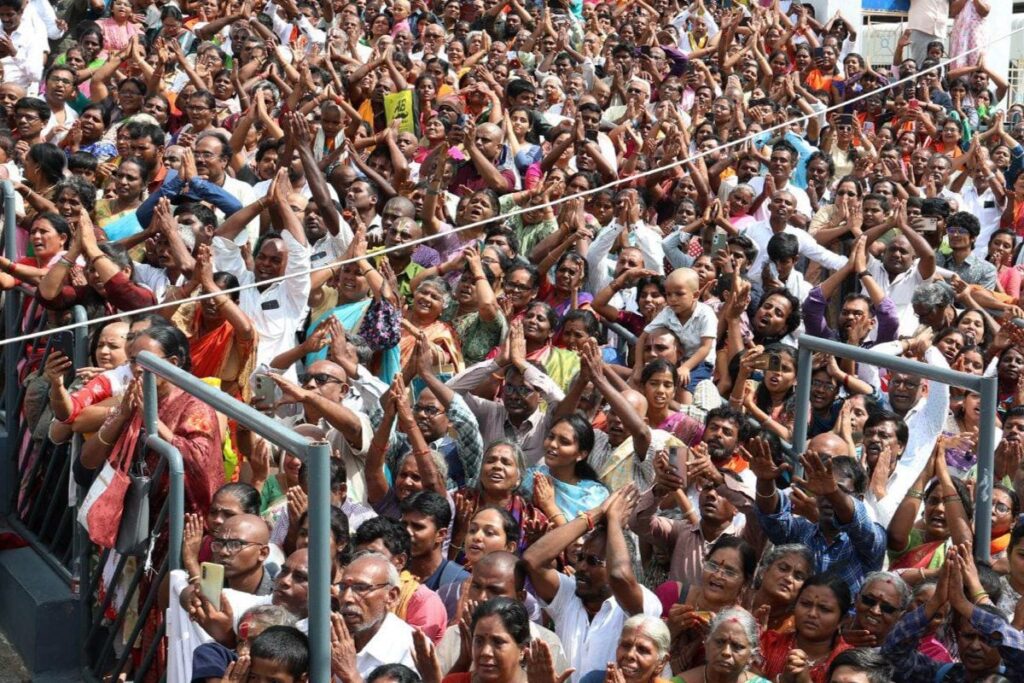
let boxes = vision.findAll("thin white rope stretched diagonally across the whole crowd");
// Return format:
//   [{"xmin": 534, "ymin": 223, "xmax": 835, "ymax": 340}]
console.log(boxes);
[{"xmin": 0, "ymin": 26, "xmax": 1024, "ymax": 347}]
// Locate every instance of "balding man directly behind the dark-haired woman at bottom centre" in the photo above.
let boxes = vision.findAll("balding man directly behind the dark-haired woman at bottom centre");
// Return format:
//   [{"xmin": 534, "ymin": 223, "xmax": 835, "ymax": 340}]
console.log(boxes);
[{"xmin": 437, "ymin": 551, "xmax": 569, "ymax": 674}]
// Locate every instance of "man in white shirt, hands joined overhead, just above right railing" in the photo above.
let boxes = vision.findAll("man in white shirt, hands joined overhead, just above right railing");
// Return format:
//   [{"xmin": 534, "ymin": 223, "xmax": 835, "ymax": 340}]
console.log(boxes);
[{"xmin": 864, "ymin": 196, "xmax": 935, "ymax": 335}]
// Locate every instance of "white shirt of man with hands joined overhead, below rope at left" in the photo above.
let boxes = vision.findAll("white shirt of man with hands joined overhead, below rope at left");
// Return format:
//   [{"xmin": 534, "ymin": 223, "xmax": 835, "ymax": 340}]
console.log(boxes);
[{"xmin": 213, "ymin": 230, "xmax": 310, "ymax": 381}]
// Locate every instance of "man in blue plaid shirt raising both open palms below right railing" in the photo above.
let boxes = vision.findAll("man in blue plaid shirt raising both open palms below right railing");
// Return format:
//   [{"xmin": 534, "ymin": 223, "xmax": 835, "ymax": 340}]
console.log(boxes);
[{"xmin": 749, "ymin": 435, "xmax": 886, "ymax": 592}]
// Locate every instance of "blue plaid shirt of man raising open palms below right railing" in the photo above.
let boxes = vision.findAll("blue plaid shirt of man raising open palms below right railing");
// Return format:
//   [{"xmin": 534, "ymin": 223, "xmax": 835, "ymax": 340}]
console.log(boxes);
[{"xmin": 758, "ymin": 490, "xmax": 886, "ymax": 595}]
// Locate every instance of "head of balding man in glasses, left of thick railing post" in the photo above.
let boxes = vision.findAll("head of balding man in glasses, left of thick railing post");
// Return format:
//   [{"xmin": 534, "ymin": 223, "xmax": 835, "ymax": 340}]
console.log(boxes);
[{"xmin": 210, "ymin": 515, "xmax": 276, "ymax": 595}]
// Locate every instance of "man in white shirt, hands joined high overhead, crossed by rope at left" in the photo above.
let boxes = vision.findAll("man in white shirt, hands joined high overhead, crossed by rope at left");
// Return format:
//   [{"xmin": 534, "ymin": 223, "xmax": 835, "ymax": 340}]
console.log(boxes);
[{"xmin": 211, "ymin": 167, "xmax": 310, "ymax": 378}]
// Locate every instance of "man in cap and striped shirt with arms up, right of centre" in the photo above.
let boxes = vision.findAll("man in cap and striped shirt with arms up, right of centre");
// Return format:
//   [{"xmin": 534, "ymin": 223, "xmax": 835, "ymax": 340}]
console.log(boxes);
[{"xmin": 630, "ymin": 432, "xmax": 764, "ymax": 585}]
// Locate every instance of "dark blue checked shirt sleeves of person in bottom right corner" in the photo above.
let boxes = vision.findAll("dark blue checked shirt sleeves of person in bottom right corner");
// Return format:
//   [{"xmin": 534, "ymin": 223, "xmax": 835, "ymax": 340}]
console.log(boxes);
[{"xmin": 882, "ymin": 605, "xmax": 1024, "ymax": 683}]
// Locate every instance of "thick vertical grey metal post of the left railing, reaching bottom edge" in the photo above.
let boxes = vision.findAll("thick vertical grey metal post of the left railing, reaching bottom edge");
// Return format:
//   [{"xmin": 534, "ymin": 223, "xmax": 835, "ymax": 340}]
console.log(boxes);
[{"xmin": 305, "ymin": 441, "xmax": 331, "ymax": 681}]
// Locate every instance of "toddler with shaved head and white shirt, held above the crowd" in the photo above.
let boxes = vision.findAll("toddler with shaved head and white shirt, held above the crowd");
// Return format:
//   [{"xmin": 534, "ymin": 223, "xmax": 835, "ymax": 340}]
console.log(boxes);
[{"xmin": 645, "ymin": 268, "xmax": 718, "ymax": 402}]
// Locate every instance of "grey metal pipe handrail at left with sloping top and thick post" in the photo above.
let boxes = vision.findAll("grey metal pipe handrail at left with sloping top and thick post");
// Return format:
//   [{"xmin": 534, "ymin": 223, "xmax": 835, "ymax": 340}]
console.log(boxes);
[{"xmin": 135, "ymin": 351, "xmax": 331, "ymax": 681}]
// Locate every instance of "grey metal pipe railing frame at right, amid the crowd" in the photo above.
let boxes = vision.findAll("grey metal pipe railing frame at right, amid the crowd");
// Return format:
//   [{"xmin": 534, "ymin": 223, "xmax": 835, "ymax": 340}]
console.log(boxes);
[{"xmin": 793, "ymin": 335, "xmax": 998, "ymax": 562}]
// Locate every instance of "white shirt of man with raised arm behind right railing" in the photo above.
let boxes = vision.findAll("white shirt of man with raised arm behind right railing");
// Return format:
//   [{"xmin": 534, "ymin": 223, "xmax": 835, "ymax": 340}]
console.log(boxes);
[{"xmin": 864, "ymin": 342, "xmax": 949, "ymax": 527}]
